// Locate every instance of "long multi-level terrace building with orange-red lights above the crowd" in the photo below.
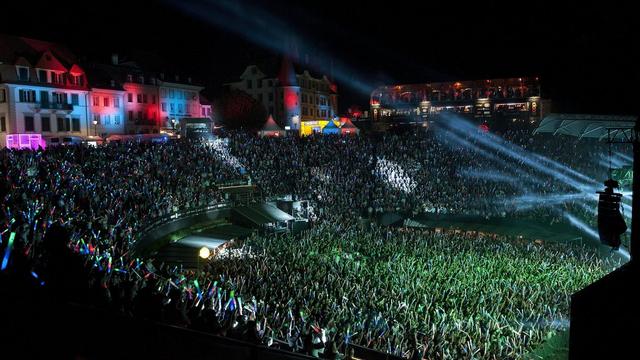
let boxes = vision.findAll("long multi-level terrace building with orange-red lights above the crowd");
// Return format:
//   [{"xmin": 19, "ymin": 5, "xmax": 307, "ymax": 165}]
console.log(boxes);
[{"xmin": 370, "ymin": 77, "xmax": 548, "ymax": 128}]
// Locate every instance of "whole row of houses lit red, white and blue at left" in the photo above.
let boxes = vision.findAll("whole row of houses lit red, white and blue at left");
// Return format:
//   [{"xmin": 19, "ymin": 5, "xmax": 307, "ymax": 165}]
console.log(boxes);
[{"xmin": 0, "ymin": 34, "xmax": 212, "ymax": 149}]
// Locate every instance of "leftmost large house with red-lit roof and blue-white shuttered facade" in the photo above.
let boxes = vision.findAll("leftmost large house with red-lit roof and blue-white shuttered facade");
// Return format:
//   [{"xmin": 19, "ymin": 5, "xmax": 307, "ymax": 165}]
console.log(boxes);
[{"xmin": 0, "ymin": 36, "xmax": 90, "ymax": 149}]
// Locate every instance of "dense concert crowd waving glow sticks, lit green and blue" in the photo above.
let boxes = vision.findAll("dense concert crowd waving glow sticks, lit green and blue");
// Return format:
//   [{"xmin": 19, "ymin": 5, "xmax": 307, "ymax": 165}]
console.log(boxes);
[{"xmin": 0, "ymin": 120, "xmax": 632, "ymax": 358}]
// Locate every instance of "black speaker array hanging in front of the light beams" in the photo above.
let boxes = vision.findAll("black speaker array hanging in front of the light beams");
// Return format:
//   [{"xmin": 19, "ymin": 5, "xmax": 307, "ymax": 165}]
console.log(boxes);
[{"xmin": 597, "ymin": 179, "xmax": 627, "ymax": 250}]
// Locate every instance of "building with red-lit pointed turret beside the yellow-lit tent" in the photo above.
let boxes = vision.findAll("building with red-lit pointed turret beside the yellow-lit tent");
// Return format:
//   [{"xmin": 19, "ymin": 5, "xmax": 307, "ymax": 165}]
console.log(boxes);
[{"xmin": 226, "ymin": 58, "xmax": 338, "ymax": 135}]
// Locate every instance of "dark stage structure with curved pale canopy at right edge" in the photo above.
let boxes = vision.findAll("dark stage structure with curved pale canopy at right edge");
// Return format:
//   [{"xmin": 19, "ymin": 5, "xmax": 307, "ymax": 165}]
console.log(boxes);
[{"xmin": 535, "ymin": 114, "xmax": 640, "ymax": 360}]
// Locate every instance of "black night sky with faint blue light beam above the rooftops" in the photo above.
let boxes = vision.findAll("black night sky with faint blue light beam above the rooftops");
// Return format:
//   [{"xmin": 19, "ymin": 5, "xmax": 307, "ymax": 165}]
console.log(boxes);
[{"xmin": 0, "ymin": 0, "xmax": 640, "ymax": 115}]
